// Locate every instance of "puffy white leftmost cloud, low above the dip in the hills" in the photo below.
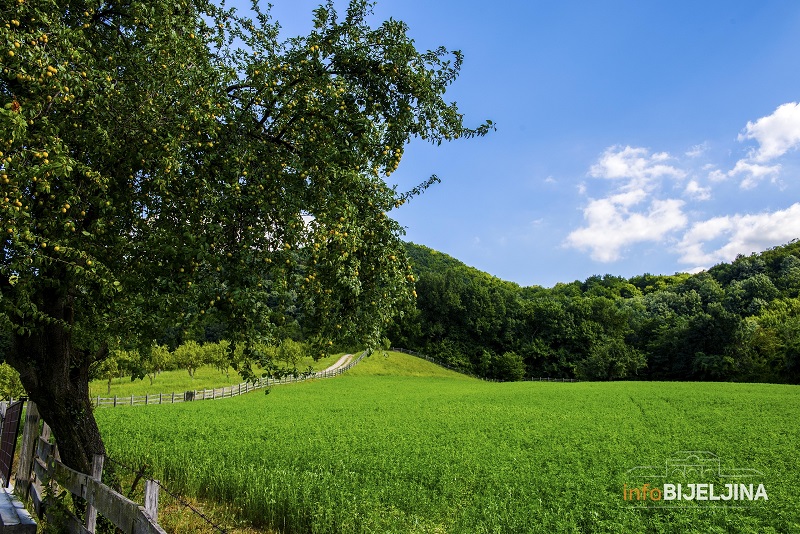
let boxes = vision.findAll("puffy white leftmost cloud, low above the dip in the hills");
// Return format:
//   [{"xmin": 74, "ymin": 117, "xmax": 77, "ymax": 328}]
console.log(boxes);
[{"xmin": 567, "ymin": 197, "xmax": 686, "ymax": 262}]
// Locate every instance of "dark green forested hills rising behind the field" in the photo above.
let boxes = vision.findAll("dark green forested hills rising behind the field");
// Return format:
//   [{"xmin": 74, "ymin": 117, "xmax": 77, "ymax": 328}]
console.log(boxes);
[{"xmin": 389, "ymin": 240, "xmax": 800, "ymax": 383}]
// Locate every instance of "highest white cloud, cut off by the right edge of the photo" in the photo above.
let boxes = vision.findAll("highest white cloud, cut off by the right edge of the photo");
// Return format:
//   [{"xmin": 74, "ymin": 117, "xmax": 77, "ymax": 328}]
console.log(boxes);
[{"xmin": 738, "ymin": 102, "xmax": 800, "ymax": 163}]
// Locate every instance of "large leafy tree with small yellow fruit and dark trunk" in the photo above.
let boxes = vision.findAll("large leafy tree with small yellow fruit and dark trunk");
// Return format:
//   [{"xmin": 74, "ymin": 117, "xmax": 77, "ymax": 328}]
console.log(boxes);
[{"xmin": 0, "ymin": 0, "xmax": 492, "ymax": 469}]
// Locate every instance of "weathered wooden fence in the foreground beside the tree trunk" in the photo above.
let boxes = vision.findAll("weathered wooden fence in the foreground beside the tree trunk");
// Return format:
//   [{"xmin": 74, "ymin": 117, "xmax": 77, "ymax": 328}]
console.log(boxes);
[{"xmin": 14, "ymin": 401, "xmax": 166, "ymax": 534}]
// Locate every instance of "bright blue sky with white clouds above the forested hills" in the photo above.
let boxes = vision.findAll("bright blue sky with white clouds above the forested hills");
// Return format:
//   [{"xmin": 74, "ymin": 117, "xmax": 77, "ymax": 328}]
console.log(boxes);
[{"xmin": 234, "ymin": 0, "xmax": 800, "ymax": 287}]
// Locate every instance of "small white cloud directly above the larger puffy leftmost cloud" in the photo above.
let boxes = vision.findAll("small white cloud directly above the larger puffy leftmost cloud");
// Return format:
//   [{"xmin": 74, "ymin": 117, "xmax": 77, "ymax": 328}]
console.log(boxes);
[{"xmin": 589, "ymin": 146, "xmax": 686, "ymax": 182}]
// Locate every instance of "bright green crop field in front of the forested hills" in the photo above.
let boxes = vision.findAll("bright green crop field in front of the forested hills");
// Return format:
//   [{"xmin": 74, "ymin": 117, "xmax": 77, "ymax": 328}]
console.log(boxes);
[{"xmin": 96, "ymin": 353, "xmax": 800, "ymax": 533}]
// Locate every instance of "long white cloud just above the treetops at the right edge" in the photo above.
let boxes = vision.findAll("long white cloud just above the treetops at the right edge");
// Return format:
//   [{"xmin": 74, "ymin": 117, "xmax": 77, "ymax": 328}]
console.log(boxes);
[{"xmin": 677, "ymin": 203, "xmax": 800, "ymax": 269}]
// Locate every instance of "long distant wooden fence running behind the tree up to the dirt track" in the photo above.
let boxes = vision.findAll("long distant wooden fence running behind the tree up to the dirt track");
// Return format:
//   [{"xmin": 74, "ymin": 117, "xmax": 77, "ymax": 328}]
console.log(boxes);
[{"xmin": 92, "ymin": 351, "xmax": 367, "ymax": 407}]
